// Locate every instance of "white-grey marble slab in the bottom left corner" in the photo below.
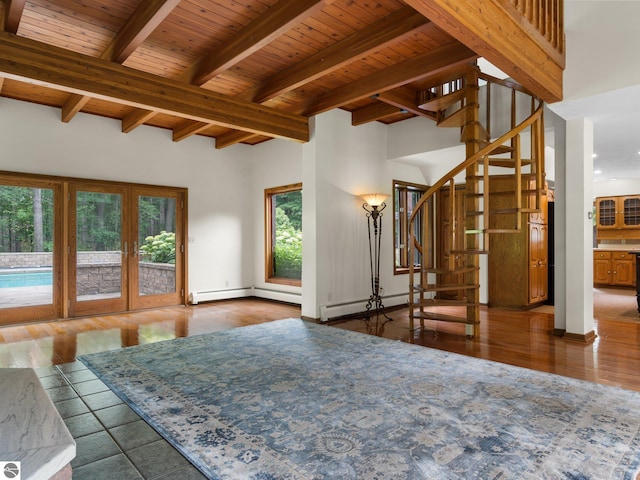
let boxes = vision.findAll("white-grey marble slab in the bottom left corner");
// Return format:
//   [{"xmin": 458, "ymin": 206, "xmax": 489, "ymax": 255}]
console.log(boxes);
[{"xmin": 0, "ymin": 368, "xmax": 76, "ymax": 480}]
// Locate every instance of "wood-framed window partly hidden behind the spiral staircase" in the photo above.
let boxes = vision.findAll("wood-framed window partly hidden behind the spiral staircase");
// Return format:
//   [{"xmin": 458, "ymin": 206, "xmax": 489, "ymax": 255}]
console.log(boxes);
[{"xmin": 393, "ymin": 180, "xmax": 433, "ymax": 275}]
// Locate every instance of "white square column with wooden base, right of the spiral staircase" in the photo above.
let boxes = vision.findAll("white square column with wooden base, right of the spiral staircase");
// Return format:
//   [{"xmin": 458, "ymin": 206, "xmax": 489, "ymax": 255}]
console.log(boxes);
[{"xmin": 565, "ymin": 118, "xmax": 595, "ymax": 341}]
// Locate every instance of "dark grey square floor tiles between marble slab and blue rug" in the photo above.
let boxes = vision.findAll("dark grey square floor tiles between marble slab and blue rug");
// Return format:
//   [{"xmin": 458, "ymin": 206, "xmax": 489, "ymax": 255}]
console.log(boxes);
[{"xmin": 35, "ymin": 361, "xmax": 205, "ymax": 480}]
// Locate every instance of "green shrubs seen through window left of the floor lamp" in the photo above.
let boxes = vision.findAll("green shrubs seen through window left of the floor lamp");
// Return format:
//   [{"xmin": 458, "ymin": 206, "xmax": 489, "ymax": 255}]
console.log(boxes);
[{"xmin": 273, "ymin": 190, "xmax": 302, "ymax": 280}]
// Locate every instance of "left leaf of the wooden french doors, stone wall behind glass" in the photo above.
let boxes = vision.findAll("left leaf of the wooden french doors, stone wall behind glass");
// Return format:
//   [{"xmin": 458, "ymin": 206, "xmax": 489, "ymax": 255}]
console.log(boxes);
[{"xmin": 70, "ymin": 189, "xmax": 128, "ymax": 315}]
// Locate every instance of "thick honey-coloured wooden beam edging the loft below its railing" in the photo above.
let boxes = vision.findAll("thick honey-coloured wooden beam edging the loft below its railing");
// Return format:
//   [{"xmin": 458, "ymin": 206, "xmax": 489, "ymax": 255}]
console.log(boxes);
[{"xmin": 405, "ymin": 0, "xmax": 564, "ymax": 103}]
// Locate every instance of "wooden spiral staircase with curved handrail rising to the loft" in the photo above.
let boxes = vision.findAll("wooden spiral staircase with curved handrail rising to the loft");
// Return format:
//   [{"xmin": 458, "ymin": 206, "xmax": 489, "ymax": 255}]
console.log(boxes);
[{"xmin": 408, "ymin": 68, "xmax": 545, "ymax": 339}]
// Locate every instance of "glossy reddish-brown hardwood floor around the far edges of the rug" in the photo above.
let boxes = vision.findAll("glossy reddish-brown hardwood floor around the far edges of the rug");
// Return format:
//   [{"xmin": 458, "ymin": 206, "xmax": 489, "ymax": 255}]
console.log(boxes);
[{"xmin": 0, "ymin": 299, "xmax": 640, "ymax": 391}]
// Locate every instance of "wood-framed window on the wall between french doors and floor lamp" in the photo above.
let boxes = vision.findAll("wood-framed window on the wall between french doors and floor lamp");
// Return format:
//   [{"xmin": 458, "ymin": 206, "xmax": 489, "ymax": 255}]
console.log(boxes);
[{"xmin": 264, "ymin": 183, "xmax": 302, "ymax": 286}]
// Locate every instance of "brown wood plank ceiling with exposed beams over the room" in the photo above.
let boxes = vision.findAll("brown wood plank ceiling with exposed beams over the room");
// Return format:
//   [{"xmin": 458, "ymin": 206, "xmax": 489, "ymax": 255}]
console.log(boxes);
[{"xmin": 0, "ymin": 0, "xmax": 477, "ymax": 148}]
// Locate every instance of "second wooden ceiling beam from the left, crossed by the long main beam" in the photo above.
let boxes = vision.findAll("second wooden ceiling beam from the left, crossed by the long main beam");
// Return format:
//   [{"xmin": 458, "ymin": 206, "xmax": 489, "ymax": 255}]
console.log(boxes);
[{"xmin": 61, "ymin": 0, "xmax": 180, "ymax": 123}]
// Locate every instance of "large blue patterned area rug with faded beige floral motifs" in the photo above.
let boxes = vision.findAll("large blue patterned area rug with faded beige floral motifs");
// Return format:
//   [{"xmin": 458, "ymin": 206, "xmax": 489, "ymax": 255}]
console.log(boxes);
[{"xmin": 81, "ymin": 319, "xmax": 640, "ymax": 480}]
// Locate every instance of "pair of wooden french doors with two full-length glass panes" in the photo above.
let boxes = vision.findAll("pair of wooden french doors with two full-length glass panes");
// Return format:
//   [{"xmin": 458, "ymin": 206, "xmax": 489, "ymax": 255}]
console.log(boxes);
[{"xmin": 68, "ymin": 183, "xmax": 184, "ymax": 316}]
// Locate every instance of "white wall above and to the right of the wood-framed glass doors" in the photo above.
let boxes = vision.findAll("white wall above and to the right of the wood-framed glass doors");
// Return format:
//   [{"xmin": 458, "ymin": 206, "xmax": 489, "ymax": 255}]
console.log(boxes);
[{"xmin": 0, "ymin": 98, "xmax": 255, "ymax": 298}]
